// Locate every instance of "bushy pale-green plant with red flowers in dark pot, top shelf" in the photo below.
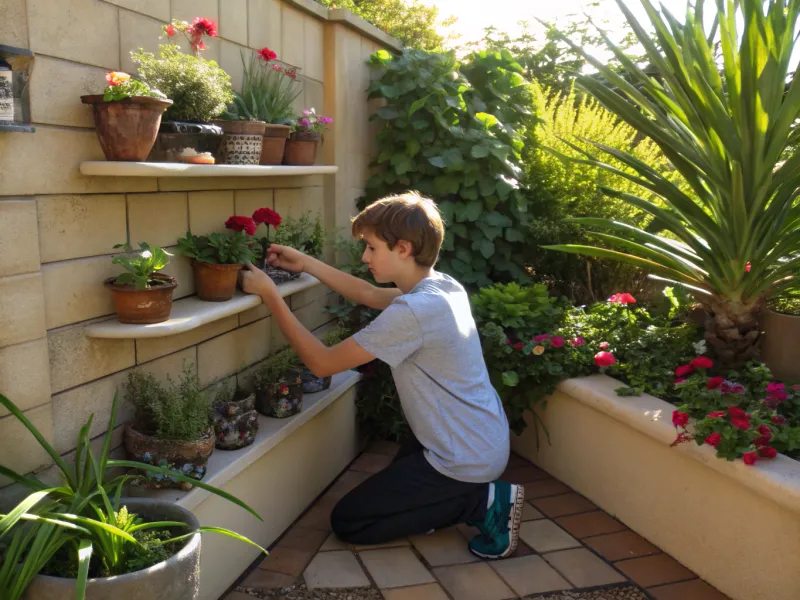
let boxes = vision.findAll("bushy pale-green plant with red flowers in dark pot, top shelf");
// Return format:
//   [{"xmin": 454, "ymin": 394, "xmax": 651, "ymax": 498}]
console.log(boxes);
[{"xmin": 131, "ymin": 17, "xmax": 233, "ymax": 163}]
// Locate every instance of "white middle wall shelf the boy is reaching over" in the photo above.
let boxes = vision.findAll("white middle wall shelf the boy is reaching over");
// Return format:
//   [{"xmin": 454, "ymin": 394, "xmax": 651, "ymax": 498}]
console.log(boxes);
[{"xmin": 86, "ymin": 273, "xmax": 320, "ymax": 339}]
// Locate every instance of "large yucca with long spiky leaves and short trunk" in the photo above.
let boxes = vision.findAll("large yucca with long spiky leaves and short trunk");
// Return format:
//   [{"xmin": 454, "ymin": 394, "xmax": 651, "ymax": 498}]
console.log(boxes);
[{"xmin": 551, "ymin": 0, "xmax": 800, "ymax": 365}]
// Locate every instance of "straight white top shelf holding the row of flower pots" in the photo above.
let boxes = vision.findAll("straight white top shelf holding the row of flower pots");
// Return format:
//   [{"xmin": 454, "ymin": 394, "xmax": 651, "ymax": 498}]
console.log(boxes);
[{"xmin": 81, "ymin": 160, "xmax": 339, "ymax": 177}]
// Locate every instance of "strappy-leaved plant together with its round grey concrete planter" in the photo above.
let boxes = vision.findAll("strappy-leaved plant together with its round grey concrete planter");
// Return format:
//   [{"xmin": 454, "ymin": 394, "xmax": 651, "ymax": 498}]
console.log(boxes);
[{"xmin": 0, "ymin": 394, "xmax": 266, "ymax": 600}]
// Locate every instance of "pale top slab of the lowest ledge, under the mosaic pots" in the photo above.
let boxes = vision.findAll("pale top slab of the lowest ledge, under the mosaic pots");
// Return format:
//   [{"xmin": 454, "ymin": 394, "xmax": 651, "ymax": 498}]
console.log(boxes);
[{"xmin": 129, "ymin": 371, "xmax": 361, "ymax": 516}]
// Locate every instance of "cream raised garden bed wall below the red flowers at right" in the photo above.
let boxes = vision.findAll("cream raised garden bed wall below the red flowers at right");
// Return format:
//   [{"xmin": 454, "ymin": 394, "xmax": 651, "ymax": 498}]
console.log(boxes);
[{"xmin": 512, "ymin": 375, "xmax": 800, "ymax": 600}]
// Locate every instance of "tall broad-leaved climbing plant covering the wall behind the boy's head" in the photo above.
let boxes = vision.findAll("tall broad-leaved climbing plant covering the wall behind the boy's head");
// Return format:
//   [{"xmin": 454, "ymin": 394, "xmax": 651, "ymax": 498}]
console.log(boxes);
[{"xmin": 362, "ymin": 50, "xmax": 532, "ymax": 285}]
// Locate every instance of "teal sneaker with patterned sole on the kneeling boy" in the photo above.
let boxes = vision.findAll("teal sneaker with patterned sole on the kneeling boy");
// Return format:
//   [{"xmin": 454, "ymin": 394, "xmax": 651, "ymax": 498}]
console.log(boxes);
[{"xmin": 469, "ymin": 481, "xmax": 525, "ymax": 558}]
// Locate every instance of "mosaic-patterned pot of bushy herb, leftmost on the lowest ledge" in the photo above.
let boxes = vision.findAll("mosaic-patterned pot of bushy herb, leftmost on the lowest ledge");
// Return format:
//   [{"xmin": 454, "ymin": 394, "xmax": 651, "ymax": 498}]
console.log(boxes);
[{"xmin": 124, "ymin": 425, "xmax": 214, "ymax": 490}]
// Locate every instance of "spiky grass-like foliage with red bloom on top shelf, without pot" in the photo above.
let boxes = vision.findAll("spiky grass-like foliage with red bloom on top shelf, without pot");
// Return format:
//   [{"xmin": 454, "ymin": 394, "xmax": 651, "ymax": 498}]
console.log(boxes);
[{"xmin": 222, "ymin": 48, "xmax": 303, "ymax": 125}]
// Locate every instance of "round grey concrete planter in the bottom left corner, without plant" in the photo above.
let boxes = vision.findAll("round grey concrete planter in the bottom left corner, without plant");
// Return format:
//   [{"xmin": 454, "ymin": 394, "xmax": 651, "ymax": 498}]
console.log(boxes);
[{"xmin": 23, "ymin": 498, "xmax": 200, "ymax": 600}]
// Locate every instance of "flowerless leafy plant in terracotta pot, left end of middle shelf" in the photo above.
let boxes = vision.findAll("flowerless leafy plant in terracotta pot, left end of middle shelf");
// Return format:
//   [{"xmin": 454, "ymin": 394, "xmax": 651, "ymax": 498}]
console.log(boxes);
[{"xmin": 104, "ymin": 242, "xmax": 178, "ymax": 324}]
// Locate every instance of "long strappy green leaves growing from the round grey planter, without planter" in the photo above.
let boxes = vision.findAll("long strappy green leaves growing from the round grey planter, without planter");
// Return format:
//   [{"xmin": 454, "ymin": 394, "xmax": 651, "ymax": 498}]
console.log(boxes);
[{"xmin": 0, "ymin": 394, "xmax": 266, "ymax": 600}]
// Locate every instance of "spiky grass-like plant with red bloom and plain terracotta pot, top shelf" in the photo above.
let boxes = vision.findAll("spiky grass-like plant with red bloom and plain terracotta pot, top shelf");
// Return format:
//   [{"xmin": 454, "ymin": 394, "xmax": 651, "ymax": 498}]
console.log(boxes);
[{"xmin": 224, "ymin": 48, "xmax": 303, "ymax": 165}]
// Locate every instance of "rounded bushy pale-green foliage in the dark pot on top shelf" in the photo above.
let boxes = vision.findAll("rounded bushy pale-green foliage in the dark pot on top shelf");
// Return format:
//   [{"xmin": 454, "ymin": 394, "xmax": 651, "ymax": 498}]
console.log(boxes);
[{"xmin": 131, "ymin": 44, "xmax": 234, "ymax": 123}]
